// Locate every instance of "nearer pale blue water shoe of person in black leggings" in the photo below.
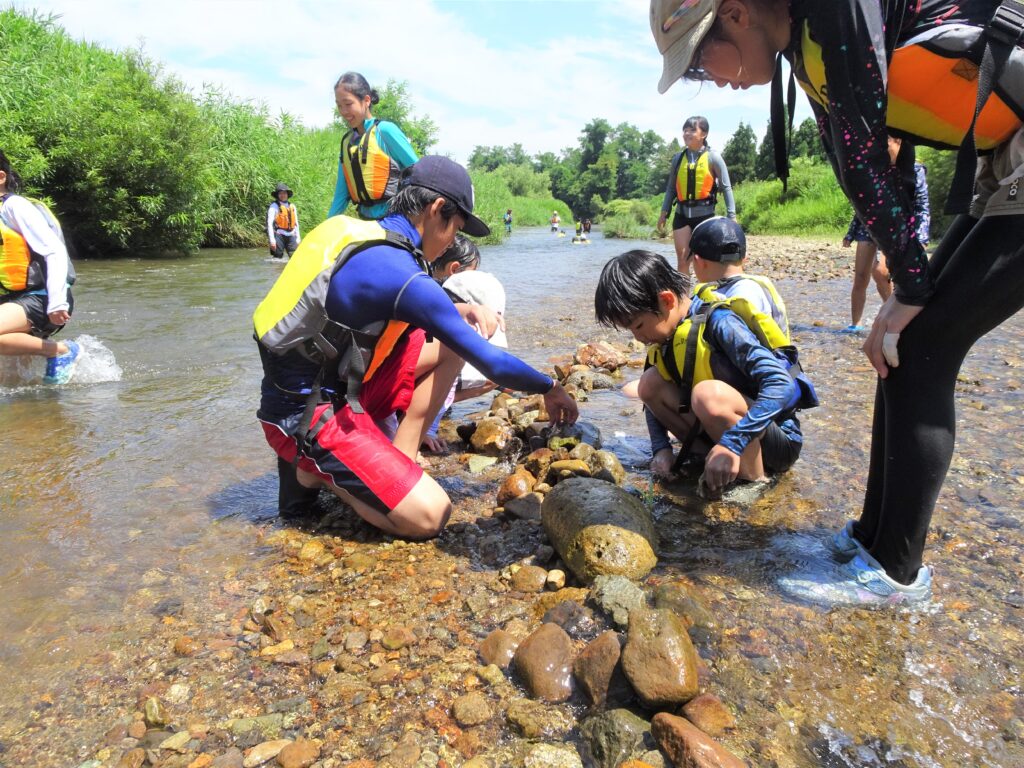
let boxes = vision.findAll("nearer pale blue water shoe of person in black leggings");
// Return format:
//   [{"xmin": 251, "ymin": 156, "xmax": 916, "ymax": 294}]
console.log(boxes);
[{"xmin": 778, "ymin": 554, "xmax": 932, "ymax": 608}]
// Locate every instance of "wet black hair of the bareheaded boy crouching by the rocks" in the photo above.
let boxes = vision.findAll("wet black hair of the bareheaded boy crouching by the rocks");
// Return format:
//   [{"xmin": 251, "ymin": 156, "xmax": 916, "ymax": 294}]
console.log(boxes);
[{"xmin": 594, "ymin": 250, "xmax": 690, "ymax": 328}]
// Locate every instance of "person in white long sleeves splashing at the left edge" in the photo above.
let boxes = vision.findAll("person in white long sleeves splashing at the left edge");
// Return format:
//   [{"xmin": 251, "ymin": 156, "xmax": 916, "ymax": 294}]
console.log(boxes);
[{"xmin": 0, "ymin": 150, "xmax": 81, "ymax": 384}]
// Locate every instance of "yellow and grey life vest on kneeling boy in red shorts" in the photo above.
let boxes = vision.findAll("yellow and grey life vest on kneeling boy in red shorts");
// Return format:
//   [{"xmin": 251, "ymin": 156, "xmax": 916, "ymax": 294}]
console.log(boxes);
[{"xmin": 253, "ymin": 216, "xmax": 426, "ymax": 413}]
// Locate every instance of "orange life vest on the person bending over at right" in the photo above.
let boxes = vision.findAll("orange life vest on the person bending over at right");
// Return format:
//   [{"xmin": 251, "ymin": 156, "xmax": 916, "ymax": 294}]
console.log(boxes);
[{"xmin": 795, "ymin": 22, "xmax": 1024, "ymax": 150}]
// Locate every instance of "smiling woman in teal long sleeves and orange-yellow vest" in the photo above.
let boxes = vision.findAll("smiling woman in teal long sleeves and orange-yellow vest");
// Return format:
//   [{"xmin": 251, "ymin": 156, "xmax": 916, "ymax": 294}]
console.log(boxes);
[{"xmin": 328, "ymin": 72, "xmax": 418, "ymax": 219}]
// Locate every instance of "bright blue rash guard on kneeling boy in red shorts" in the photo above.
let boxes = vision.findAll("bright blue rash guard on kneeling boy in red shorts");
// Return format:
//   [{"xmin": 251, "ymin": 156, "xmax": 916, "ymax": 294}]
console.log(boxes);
[{"xmin": 260, "ymin": 215, "xmax": 554, "ymax": 421}]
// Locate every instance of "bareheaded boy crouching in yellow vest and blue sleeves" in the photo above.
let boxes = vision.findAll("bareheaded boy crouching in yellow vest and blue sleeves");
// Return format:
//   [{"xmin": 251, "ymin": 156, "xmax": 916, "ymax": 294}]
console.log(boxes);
[{"xmin": 594, "ymin": 250, "xmax": 817, "ymax": 495}]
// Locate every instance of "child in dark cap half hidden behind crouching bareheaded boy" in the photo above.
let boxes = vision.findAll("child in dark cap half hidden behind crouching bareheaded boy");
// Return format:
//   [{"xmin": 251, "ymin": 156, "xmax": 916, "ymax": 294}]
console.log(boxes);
[{"xmin": 690, "ymin": 216, "xmax": 790, "ymax": 336}]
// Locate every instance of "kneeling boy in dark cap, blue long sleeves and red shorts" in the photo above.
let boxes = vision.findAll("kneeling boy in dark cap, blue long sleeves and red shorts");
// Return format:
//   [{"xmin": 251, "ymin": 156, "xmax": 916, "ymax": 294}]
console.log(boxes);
[{"xmin": 257, "ymin": 156, "xmax": 578, "ymax": 539}]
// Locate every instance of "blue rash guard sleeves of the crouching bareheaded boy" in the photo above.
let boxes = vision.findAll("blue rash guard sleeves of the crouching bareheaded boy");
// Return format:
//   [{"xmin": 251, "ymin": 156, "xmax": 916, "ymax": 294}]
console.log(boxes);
[{"xmin": 644, "ymin": 300, "xmax": 804, "ymax": 456}]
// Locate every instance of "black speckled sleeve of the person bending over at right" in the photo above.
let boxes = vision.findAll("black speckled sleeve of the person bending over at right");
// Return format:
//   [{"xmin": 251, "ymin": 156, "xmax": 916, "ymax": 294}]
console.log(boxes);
[{"xmin": 791, "ymin": 0, "xmax": 933, "ymax": 305}]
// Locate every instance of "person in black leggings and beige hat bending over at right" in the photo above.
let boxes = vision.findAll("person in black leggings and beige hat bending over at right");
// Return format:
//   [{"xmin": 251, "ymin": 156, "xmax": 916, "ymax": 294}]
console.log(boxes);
[{"xmin": 650, "ymin": 0, "xmax": 1024, "ymax": 605}]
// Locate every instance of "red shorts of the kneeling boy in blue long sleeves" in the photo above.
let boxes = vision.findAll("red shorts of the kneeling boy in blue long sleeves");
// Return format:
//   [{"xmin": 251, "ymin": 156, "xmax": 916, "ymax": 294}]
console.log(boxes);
[{"xmin": 260, "ymin": 329, "xmax": 426, "ymax": 514}]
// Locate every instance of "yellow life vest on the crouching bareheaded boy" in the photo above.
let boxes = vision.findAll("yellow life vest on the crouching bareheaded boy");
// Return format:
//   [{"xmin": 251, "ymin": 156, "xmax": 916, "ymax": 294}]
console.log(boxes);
[{"xmin": 647, "ymin": 284, "xmax": 796, "ymax": 413}]
